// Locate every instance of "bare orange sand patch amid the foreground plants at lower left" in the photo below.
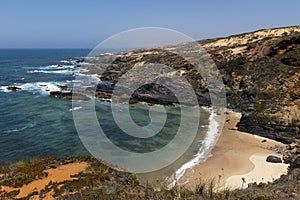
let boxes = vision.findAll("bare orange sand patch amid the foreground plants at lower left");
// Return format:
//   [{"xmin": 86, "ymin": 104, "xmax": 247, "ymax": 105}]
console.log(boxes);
[{"xmin": 1, "ymin": 162, "xmax": 88, "ymax": 199}]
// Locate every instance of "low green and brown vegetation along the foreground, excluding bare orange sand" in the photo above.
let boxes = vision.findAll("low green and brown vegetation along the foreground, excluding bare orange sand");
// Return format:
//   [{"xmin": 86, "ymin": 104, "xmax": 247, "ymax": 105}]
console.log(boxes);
[{"xmin": 0, "ymin": 156, "xmax": 300, "ymax": 200}]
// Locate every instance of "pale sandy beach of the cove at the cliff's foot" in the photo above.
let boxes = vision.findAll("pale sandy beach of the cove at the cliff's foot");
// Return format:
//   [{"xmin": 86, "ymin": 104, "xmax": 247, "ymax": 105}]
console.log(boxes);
[{"xmin": 179, "ymin": 112, "xmax": 288, "ymax": 189}]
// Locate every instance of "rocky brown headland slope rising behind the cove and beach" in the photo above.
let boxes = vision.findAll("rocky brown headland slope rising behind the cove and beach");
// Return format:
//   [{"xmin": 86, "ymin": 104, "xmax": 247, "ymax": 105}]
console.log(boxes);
[{"xmin": 43, "ymin": 26, "xmax": 300, "ymax": 143}]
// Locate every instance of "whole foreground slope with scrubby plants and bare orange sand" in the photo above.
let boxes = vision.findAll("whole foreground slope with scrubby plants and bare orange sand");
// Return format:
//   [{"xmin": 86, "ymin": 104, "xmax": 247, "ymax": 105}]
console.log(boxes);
[{"xmin": 0, "ymin": 152, "xmax": 300, "ymax": 200}]
